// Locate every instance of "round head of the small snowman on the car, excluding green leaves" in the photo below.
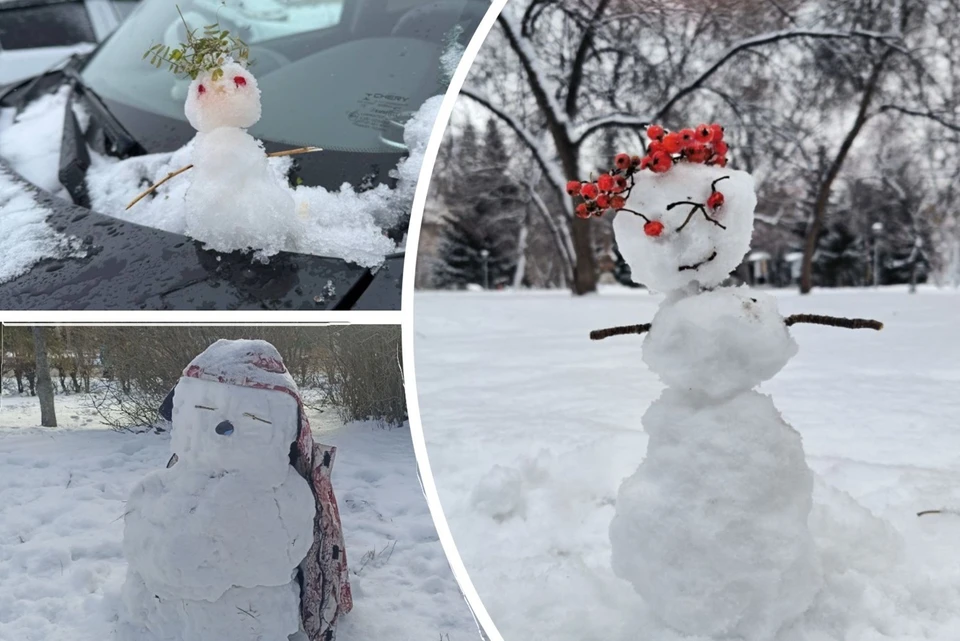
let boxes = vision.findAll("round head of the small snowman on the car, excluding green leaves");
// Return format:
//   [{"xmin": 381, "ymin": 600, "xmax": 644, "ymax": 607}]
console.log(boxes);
[{"xmin": 184, "ymin": 62, "xmax": 260, "ymax": 133}]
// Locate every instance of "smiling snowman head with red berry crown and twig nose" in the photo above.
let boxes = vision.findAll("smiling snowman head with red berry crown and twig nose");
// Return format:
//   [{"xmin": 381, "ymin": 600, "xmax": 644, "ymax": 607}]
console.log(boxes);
[{"xmin": 567, "ymin": 125, "xmax": 757, "ymax": 291}]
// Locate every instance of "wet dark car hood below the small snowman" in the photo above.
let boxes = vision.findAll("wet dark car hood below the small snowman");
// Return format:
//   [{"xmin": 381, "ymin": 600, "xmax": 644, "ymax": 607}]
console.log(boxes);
[{"xmin": 0, "ymin": 160, "xmax": 403, "ymax": 310}]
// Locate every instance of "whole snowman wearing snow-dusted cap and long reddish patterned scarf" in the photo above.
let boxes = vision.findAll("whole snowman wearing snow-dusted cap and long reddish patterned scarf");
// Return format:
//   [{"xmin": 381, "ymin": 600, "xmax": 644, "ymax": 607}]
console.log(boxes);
[{"xmin": 122, "ymin": 340, "xmax": 352, "ymax": 641}]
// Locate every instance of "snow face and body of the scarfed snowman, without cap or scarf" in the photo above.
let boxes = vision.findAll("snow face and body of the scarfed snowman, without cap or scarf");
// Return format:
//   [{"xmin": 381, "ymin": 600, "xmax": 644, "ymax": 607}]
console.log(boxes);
[{"xmin": 122, "ymin": 377, "xmax": 316, "ymax": 641}]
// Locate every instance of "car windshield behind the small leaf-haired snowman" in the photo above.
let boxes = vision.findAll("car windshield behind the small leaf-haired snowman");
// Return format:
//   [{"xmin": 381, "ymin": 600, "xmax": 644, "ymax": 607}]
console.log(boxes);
[{"xmin": 83, "ymin": 0, "xmax": 490, "ymax": 153}]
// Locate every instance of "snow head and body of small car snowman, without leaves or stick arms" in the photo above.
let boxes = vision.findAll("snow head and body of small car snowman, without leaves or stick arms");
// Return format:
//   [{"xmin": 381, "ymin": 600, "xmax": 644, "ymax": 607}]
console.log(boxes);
[{"xmin": 185, "ymin": 62, "xmax": 300, "ymax": 256}]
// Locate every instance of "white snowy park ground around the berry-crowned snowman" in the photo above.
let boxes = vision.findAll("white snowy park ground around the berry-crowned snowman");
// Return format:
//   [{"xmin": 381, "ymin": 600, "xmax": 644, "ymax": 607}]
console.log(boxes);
[{"xmin": 414, "ymin": 288, "xmax": 960, "ymax": 641}]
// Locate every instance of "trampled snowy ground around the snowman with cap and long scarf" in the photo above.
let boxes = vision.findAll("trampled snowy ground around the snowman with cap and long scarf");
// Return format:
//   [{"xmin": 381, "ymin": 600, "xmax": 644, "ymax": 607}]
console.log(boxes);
[{"xmin": 0, "ymin": 396, "xmax": 479, "ymax": 641}]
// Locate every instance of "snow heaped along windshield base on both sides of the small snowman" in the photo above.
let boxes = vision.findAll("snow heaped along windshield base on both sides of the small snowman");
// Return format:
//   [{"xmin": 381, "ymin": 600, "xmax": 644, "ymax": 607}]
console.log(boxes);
[{"xmin": 86, "ymin": 96, "xmax": 442, "ymax": 267}]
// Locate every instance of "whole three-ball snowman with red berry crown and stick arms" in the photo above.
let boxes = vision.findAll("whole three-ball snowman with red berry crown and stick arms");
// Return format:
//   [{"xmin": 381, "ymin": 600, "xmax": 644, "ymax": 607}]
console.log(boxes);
[{"xmin": 567, "ymin": 125, "xmax": 881, "ymax": 641}]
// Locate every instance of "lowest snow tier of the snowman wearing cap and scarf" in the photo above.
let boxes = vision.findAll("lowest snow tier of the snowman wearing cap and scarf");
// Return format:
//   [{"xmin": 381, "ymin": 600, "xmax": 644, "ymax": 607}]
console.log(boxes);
[{"xmin": 119, "ymin": 573, "xmax": 300, "ymax": 641}]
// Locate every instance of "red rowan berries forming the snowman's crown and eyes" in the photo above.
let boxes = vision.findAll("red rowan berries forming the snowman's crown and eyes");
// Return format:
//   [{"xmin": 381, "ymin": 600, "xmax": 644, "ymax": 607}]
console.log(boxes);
[{"xmin": 567, "ymin": 124, "xmax": 727, "ymax": 225}]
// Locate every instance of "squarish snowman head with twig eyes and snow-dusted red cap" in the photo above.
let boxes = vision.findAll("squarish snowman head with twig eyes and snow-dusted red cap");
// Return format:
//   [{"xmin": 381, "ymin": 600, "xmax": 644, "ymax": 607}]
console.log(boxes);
[{"xmin": 171, "ymin": 340, "xmax": 303, "ymax": 486}]
